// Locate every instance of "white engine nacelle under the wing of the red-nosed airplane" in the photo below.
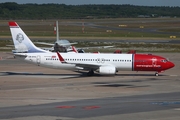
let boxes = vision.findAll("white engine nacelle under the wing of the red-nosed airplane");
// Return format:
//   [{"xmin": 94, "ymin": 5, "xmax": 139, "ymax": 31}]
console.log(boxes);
[{"xmin": 99, "ymin": 66, "xmax": 116, "ymax": 75}]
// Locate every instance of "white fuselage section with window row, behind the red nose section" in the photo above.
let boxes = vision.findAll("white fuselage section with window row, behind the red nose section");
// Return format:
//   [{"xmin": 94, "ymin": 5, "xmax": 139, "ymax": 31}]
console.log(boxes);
[{"xmin": 20, "ymin": 53, "xmax": 133, "ymax": 71}]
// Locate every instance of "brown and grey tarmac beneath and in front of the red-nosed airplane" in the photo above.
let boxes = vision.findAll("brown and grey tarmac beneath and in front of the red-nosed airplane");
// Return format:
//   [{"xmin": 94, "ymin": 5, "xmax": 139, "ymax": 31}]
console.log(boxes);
[{"xmin": 0, "ymin": 52, "xmax": 180, "ymax": 120}]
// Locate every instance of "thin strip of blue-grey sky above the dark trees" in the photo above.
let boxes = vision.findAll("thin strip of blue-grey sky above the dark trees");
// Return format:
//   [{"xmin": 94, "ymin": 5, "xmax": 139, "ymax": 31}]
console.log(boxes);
[{"xmin": 0, "ymin": 0, "xmax": 180, "ymax": 7}]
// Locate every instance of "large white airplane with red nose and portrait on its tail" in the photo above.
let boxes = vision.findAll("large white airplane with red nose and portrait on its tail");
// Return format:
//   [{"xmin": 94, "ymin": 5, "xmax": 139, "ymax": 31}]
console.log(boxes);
[{"xmin": 9, "ymin": 22, "xmax": 175, "ymax": 76}]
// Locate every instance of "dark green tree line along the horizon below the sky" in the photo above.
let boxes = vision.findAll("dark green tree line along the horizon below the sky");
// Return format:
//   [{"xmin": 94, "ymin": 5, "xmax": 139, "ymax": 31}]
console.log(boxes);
[{"xmin": 0, "ymin": 2, "xmax": 180, "ymax": 20}]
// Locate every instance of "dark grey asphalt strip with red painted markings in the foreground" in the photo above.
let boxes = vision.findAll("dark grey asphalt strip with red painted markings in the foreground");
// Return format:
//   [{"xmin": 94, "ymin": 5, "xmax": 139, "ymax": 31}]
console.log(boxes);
[{"xmin": 0, "ymin": 92, "xmax": 180, "ymax": 119}]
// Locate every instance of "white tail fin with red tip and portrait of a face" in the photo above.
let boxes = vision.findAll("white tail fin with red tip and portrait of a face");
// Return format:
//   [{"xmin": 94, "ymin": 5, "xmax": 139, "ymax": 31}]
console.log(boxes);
[{"xmin": 9, "ymin": 21, "xmax": 48, "ymax": 53}]
